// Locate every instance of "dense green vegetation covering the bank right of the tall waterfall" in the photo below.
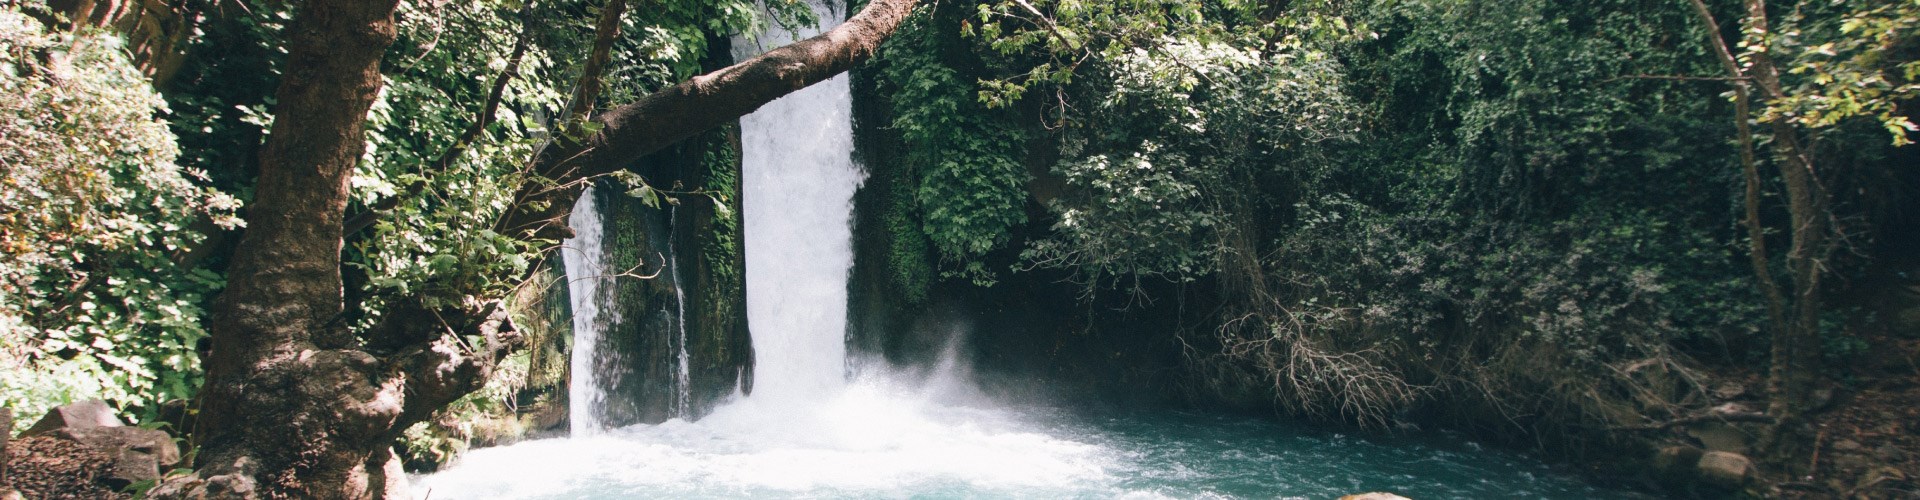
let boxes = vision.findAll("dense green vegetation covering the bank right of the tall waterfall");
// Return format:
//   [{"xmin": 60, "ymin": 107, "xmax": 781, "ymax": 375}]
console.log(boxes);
[{"xmin": 879, "ymin": 0, "xmax": 1920, "ymax": 469}]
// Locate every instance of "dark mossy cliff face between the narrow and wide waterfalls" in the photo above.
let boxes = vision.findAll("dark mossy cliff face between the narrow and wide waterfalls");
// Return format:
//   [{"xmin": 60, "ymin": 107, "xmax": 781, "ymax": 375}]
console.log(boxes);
[{"xmin": 576, "ymin": 119, "xmax": 753, "ymax": 427}]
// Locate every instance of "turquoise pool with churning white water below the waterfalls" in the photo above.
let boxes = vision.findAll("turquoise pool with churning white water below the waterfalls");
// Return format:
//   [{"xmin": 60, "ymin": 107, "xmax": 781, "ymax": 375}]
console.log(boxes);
[{"xmin": 413, "ymin": 375, "xmax": 1632, "ymax": 500}]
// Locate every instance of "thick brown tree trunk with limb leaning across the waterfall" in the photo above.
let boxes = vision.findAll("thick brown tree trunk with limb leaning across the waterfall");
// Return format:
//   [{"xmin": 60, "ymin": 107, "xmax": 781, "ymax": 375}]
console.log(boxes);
[{"xmin": 154, "ymin": 0, "xmax": 916, "ymax": 498}]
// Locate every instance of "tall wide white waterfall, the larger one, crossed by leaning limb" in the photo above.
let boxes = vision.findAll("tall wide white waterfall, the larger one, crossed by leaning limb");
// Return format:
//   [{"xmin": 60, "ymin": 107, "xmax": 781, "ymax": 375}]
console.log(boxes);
[{"xmin": 737, "ymin": 0, "xmax": 866, "ymax": 402}]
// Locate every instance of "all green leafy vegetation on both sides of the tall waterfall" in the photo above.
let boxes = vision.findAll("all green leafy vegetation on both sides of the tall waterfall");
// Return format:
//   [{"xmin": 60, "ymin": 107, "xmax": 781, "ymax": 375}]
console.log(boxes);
[{"xmin": 0, "ymin": 0, "xmax": 1920, "ymax": 496}]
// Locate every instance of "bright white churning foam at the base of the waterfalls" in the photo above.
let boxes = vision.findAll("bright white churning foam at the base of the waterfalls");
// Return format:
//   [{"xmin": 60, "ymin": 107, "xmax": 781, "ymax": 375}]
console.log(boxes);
[{"xmin": 417, "ymin": 365, "xmax": 1114, "ymax": 498}]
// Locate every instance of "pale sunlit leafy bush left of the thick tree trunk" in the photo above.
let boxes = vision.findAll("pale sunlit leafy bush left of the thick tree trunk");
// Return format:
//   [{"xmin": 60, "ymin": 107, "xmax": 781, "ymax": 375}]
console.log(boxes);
[{"xmin": 0, "ymin": 6, "xmax": 240, "ymax": 423}]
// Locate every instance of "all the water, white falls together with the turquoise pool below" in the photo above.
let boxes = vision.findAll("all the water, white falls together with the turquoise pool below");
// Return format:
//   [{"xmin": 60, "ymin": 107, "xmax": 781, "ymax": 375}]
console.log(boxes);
[{"xmin": 415, "ymin": 6, "xmax": 1643, "ymax": 500}]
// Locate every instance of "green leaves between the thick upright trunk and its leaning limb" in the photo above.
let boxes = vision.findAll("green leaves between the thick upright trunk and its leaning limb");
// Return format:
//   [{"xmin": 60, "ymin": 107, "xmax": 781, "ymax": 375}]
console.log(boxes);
[{"xmin": 348, "ymin": 0, "xmax": 768, "ymax": 321}]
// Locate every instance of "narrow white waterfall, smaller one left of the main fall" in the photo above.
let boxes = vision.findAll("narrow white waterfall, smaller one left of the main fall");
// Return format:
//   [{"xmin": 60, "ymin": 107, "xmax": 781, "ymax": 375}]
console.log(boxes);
[{"xmin": 561, "ymin": 187, "xmax": 611, "ymax": 435}]
